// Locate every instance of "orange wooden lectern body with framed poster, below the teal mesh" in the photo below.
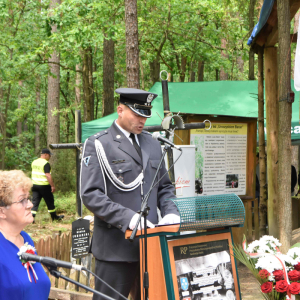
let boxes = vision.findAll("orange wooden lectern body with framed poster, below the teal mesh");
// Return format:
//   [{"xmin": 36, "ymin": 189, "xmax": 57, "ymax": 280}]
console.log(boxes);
[{"xmin": 126, "ymin": 225, "xmax": 241, "ymax": 300}]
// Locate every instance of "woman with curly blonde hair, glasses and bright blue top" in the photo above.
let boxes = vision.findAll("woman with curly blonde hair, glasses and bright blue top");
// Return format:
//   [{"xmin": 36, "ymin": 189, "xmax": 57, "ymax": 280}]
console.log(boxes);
[{"xmin": 0, "ymin": 170, "xmax": 50, "ymax": 300}]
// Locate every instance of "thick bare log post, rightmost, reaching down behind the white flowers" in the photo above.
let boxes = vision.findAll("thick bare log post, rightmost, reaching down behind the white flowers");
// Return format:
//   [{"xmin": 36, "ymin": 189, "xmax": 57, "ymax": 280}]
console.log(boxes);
[{"xmin": 277, "ymin": 0, "xmax": 292, "ymax": 253}]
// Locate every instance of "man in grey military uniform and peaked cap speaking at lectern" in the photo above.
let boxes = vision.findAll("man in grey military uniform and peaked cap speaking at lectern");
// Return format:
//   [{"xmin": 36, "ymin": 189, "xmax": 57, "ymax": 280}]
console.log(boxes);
[{"xmin": 81, "ymin": 88, "xmax": 180, "ymax": 300}]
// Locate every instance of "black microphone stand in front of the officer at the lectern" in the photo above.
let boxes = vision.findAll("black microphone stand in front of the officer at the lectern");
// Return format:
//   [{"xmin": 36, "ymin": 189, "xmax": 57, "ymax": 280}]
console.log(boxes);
[{"xmin": 129, "ymin": 144, "xmax": 170, "ymax": 300}]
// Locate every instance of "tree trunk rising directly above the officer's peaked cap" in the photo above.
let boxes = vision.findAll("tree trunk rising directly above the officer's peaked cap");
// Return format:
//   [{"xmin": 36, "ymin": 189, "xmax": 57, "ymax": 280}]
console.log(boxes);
[{"xmin": 125, "ymin": 0, "xmax": 140, "ymax": 89}]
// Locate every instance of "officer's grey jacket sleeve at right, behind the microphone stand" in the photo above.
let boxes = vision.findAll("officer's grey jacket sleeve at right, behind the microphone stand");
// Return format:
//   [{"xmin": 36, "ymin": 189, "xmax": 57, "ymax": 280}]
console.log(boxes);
[{"xmin": 157, "ymin": 145, "xmax": 179, "ymax": 217}]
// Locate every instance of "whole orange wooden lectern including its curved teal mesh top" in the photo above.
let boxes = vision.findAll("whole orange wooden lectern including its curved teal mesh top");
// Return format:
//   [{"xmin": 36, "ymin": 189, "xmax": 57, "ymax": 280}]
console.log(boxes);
[{"xmin": 126, "ymin": 194, "xmax": 245, "ymax": 300}]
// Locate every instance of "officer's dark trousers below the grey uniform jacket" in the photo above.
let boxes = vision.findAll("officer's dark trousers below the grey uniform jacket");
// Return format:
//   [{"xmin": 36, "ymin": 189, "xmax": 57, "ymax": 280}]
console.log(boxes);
[{"xmin": 93, "ymin": 259, "xmax": 141, "ymax": 300}]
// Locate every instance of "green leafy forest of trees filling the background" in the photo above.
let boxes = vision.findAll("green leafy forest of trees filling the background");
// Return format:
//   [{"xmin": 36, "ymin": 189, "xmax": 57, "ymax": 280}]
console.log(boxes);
[{"xmin": 0, "ymin": 0, "xmax": 284, "ymax": 192}]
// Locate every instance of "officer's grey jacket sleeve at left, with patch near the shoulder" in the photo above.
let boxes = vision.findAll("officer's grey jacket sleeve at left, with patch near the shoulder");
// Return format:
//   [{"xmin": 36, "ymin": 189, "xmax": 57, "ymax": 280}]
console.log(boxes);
[{"xmin": 80, "ymin": 139, "xmax": 135, "ymax": 232}]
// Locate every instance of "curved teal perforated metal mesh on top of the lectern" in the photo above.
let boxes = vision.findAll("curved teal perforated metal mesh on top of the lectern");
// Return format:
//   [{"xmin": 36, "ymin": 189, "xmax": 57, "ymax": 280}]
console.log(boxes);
[{"xmin": 166, "ymin": 194, "xmax": 245, "ymax": 231}]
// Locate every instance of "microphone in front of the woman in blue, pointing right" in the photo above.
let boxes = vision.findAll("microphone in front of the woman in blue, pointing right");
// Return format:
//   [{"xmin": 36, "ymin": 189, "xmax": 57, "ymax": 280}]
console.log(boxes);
[{"xmin": 20, "ymin": 253, "xmax": 83, "ymax": 271}]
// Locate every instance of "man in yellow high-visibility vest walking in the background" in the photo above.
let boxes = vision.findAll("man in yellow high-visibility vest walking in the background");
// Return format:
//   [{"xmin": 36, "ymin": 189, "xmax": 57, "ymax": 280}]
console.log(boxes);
[{"xmin": 31, "ymin": 149, "xmax": 64, "ymax": 223}]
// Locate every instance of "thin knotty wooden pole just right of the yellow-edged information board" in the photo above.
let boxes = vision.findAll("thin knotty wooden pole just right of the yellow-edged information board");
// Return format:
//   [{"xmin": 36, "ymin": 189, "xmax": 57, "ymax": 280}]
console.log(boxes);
[{"xmin": 258, "ymin": 48, "xmax": 268, "ymax": 236}]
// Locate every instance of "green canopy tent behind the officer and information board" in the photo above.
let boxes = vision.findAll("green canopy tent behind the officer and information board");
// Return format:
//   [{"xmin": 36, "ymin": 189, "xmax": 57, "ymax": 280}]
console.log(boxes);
[{"xmin": 82, "ymin": 80, "xmax": 300, "ymax": 145}]
